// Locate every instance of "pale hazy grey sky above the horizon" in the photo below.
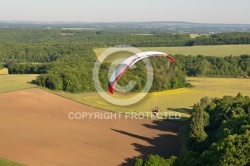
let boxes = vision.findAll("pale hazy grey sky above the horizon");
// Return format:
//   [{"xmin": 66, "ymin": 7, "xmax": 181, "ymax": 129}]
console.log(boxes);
[{"xmin": 0, "ymin": 0, "xmax": 250, "ymax": 24}]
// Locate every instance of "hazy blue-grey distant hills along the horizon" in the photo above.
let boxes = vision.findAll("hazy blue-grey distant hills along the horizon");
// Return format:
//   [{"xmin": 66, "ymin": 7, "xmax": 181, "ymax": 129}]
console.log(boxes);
[{"xmin": 0, "ymin": 21, "xmax": 250, "ymax": 34}]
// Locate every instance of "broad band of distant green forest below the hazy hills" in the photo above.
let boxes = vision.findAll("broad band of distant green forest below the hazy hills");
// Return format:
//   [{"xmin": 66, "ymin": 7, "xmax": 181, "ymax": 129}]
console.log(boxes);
[{"xmin": 0, "ymin": 29, "xmax": 250, "ymax": 50}]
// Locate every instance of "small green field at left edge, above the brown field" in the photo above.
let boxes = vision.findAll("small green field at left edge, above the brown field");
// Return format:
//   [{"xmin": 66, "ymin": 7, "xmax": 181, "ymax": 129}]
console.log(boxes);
[{"xmin": 0, "ymin": 69, "xmax": 38, "ymax": 93}]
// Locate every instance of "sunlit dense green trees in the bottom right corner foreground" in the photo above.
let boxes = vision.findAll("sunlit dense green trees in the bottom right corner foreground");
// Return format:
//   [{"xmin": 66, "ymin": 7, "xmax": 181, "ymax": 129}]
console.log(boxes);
[{"xmin": 135, "ymin": 93, "xmax": 250, "ymax": 166}]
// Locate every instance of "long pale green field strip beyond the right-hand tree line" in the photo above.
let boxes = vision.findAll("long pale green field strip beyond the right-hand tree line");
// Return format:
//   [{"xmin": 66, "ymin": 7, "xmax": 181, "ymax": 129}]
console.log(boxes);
[{"xmin": 94, "ymin": 44, "xmax": 250, "ymax": 57}]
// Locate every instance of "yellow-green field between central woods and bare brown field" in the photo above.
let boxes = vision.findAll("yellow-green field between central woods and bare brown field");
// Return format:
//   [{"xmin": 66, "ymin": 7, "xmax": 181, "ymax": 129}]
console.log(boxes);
[{"xmin": 47, "ymin": 77, "xmax": 250, "ymax": 119}]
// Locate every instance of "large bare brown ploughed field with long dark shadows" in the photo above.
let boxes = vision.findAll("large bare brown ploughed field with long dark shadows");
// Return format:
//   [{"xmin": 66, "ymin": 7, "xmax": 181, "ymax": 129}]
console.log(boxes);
[{"xmin": 0, "ymin": 89, "xmax": 184, "ymax": 166}]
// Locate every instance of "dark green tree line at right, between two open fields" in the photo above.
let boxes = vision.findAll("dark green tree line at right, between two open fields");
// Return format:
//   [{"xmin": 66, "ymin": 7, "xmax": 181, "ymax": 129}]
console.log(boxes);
[{"xmin": 174, "ymin": 55, "xmax": 250, "ymax": 77}]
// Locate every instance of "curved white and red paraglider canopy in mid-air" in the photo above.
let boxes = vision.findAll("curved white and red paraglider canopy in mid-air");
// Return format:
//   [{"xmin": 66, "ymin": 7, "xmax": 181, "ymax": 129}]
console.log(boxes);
[{"xmin": 108, "ymin": 51, "xmax": 175, "ymax": 94}]
